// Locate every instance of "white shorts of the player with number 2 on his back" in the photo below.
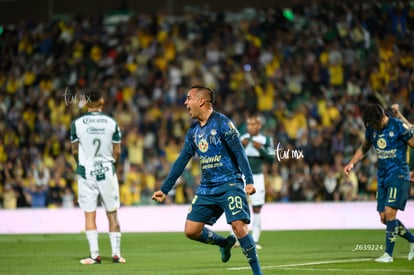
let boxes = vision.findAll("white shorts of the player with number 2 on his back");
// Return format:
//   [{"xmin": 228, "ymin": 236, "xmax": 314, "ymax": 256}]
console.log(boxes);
[{"xmin": 78, "ymin": 164, "xmax": 120, "ymax": 212}]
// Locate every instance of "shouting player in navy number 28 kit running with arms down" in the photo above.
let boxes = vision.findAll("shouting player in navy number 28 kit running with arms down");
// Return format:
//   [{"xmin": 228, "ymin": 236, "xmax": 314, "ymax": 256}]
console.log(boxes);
[{"xmin": 152, "ymin": 85, "xmax": 262, "ymax": 275}]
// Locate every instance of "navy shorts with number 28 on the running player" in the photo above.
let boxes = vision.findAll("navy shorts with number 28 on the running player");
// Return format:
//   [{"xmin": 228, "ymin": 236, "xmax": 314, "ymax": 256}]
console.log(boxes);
[{"xmin": 187, "ymin": 183, "xmax": 250, "ymax": 225}]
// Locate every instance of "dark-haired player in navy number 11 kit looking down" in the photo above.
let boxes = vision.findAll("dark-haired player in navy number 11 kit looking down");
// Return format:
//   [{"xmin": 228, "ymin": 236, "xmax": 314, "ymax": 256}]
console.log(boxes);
[{"xmin": 344, "ymin": 104, "xmax": 414, "ymax": 263}]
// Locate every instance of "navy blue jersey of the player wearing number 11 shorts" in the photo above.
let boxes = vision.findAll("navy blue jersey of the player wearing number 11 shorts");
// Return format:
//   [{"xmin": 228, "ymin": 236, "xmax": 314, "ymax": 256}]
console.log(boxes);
[{"xmin": 365, "ymin": 117, "xmax": 413, "ymax": 184}]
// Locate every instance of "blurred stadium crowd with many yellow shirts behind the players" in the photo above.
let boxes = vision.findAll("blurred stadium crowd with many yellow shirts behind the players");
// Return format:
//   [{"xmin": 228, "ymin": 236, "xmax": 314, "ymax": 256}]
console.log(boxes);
[{"xmin": 0, "ymin": 1, "xmax": 414, "ymax": 208}]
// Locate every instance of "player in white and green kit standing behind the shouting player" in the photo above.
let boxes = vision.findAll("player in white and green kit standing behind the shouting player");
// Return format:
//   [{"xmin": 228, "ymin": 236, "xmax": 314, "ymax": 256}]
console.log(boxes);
[{"xmin": 240, "ymin": 115, "xmax": 275, "ymax": 249}]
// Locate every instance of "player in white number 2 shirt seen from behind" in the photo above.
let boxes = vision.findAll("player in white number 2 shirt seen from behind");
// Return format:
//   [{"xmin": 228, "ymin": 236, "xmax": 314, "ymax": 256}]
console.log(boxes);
[{"xmin": 70, "ymin": 89, "xmax": 126, "ymax": 265}]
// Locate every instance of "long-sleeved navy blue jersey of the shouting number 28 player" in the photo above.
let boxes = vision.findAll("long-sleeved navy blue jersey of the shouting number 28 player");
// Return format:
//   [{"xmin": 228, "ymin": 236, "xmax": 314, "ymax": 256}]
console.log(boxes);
[{"xmin": 161, "ymin": 111, "xmax": 253, "ymax": 195}]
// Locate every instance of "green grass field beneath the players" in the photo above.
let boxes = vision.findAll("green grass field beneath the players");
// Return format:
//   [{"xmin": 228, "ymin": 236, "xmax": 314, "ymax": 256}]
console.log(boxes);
[{"xmin": 0, "ymin": 230, "xmax": 414, "ymax": 275}]
